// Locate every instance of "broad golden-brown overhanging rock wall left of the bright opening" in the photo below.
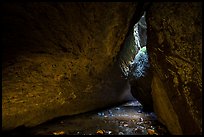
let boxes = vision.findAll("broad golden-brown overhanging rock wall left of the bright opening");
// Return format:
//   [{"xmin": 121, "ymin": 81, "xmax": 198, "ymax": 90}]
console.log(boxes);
[{"xmin": 1, "ymin": 2, "xmax": 141, "ymax": 130}]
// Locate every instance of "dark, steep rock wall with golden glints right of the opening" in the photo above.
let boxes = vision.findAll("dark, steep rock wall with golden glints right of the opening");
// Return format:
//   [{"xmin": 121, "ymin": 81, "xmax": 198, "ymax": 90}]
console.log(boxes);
[{"xmin": 147, "ymin": 2, "xmax": 202, "ymax": 134}]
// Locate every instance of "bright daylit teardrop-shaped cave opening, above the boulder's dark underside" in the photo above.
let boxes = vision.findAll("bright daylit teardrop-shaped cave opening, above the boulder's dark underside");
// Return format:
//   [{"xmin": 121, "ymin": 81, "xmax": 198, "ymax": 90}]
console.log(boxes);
[{"xmin": 120, "ymin": 12, "xmax": 149, "ymax": 79}]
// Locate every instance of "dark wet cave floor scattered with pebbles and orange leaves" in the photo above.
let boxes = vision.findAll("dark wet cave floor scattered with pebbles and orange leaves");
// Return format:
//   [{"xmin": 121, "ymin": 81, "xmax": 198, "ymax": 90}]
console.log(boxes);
[{"xmin": 6, "ymin": 100, "xmax": 169, "ymax": 135}]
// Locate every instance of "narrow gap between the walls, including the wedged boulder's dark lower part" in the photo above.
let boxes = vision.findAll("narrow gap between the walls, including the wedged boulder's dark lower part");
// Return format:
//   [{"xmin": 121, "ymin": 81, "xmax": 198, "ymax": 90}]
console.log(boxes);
[{"xmin": 119, "ymin": 12, "xmax": 153, "ymax": 111}]
